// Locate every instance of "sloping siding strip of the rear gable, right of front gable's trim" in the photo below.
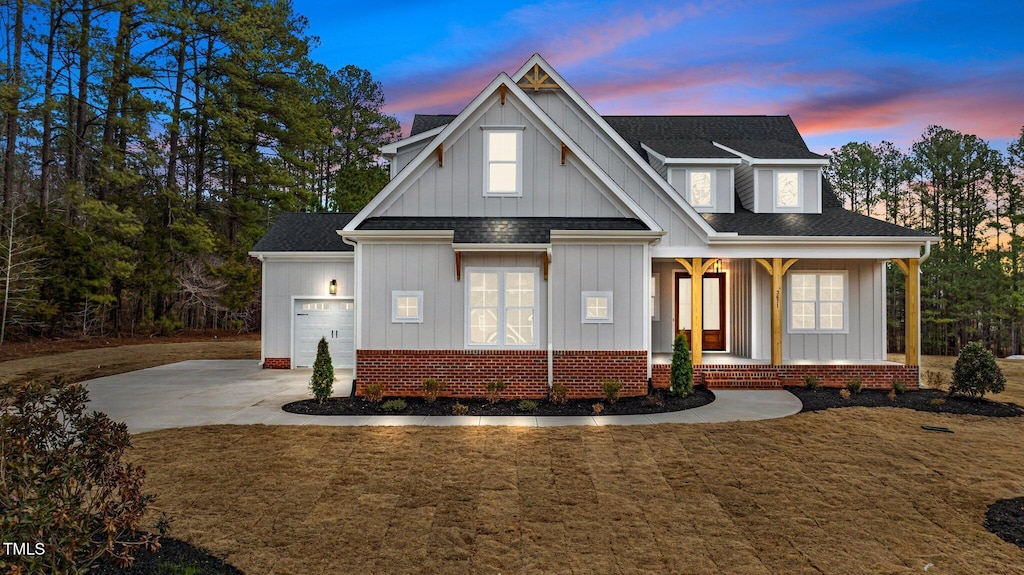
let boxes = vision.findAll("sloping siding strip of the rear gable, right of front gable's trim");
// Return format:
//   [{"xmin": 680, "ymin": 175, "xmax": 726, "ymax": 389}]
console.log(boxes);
[{"xmin": 526, "ymin": 90, "xmax": 705, "ymax": 246}]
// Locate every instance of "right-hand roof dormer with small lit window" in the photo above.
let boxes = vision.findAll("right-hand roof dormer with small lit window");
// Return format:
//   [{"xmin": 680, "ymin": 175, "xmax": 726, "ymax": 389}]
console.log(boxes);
[{"xmin": 714, "ymin": 140, "xmax": 828, "ymax": 214}]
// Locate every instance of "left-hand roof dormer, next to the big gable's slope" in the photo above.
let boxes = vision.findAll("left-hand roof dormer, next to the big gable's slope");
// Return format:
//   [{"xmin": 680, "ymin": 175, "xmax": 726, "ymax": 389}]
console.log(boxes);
[{"xmin": 640, "ymin": 138, "xmax": 742, "ymax": 214}]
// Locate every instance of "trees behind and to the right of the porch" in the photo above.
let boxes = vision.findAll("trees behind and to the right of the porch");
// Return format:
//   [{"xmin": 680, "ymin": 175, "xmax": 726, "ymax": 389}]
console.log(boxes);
[{"xmin": 825, "ymin": 126, "xmax": 1024, "ymax": 355}]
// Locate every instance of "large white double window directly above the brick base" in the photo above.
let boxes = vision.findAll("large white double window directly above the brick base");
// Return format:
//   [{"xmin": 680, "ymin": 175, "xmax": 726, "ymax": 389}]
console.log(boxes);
[{"xmin": 466, "ymin": 269, "xmax": 538, "ymax": 347}]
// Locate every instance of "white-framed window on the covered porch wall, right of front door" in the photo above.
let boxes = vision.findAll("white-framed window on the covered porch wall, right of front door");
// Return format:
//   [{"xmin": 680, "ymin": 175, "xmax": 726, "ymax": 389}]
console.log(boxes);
[{"xmin": 790, "ymin": 271, "xmax": 848, "ymax": 333}]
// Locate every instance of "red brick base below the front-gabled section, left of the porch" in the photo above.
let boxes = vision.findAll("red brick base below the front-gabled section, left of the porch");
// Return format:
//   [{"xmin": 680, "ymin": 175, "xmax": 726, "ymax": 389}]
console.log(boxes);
[{"xmin": 355, "ymin": 350, "xmax": 647, "ymax": 399}]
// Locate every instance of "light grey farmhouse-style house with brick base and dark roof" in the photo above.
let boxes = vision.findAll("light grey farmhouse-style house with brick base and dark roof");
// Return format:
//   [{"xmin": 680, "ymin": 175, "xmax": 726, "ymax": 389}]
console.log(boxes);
[{"xmin": 252, "ymin": 55, "xmax": 937, "ymax": 397}]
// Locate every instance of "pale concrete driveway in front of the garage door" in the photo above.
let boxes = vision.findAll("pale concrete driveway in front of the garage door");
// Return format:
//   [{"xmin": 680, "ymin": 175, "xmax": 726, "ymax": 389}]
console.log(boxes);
[{"xmin": 85, "ymin": 359, "xmax": 352, "ymax": 433}]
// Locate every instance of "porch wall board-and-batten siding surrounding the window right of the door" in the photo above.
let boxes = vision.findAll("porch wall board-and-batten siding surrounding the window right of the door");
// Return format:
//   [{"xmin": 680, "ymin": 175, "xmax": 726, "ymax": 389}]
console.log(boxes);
[{"xmin": 753, "ymin": 260, "xmax": 886, "ymax": 361}]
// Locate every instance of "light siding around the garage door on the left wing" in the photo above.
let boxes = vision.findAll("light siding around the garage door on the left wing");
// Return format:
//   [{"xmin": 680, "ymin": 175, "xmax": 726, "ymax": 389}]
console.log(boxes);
[{"xmin": 262, "ymin": 259, "xmax": 355, "ymax": 357}]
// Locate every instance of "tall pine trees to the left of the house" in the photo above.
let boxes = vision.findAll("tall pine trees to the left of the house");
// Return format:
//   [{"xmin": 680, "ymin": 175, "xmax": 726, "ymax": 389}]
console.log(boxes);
[{"xmin": 0, "ymin": 0, "xmax": 399, "ymax": 343}]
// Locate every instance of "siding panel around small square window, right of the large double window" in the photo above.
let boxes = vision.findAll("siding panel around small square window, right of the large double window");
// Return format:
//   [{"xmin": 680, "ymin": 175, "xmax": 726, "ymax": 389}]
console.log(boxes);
[{"xmin": 551, "ymin": 239, "xmax": 647, "ymax": 350}]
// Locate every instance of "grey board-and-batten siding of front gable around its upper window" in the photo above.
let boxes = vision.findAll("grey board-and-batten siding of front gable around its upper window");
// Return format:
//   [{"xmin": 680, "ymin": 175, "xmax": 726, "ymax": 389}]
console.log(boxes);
[{"xmin": 374, "ymin": 96, "xmax": 632, "ymax": 218}]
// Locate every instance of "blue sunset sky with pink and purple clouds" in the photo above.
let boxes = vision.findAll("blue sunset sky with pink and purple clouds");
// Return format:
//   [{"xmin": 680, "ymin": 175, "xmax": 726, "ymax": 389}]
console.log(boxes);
[{"xmin": 294, "ymin": 0, "xmax": 1024, "ymax": 153}]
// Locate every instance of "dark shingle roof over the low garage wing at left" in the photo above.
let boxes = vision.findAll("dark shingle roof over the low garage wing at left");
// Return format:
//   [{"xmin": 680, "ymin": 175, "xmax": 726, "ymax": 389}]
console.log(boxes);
[{"xmin": 252, "ymin": 212, "xmax": 355, "ymax": 252}]
